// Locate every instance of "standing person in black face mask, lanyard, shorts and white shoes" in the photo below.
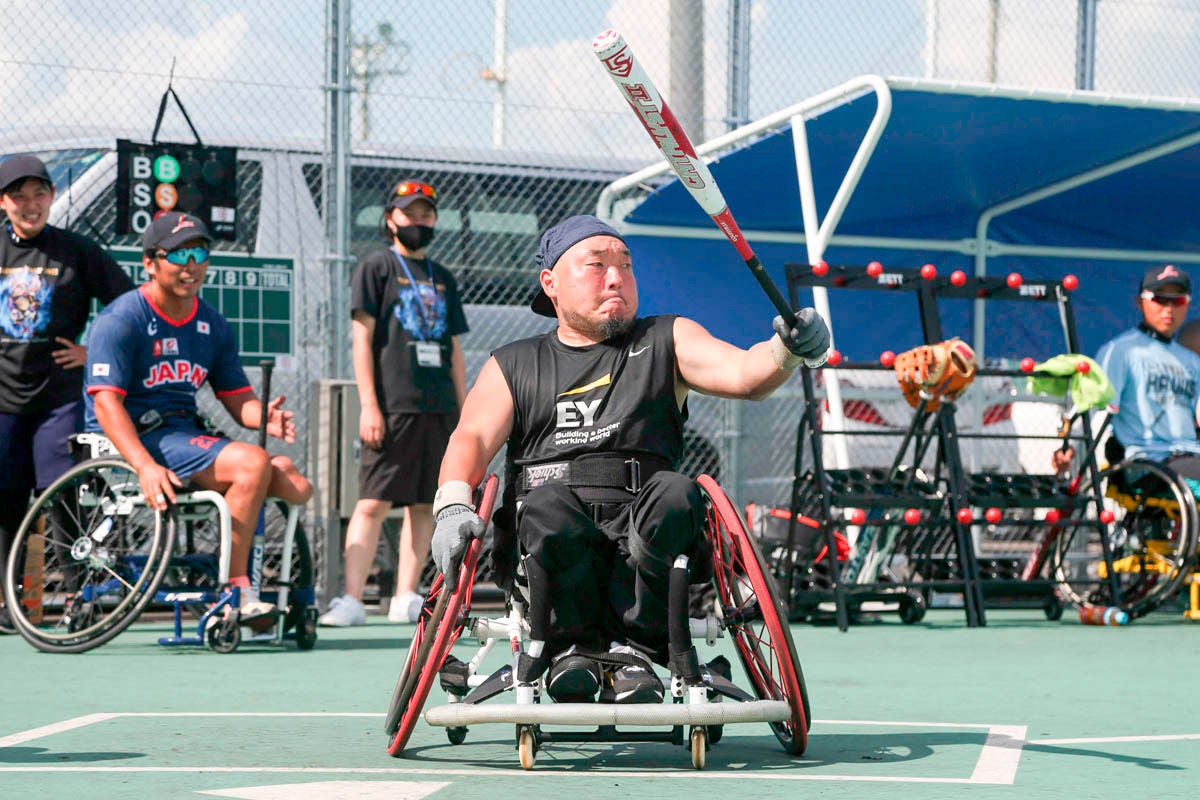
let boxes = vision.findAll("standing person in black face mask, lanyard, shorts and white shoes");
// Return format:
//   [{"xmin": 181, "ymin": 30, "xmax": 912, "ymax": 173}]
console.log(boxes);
[{"xmin": 318, "ymin": 180, "xmax": 468, "ymax": 627}]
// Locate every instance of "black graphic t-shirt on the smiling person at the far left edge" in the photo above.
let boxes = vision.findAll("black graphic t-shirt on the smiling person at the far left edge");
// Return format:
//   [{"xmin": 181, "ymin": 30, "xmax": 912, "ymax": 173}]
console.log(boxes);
[{"xmin": 0, "ymin": 225, "xmax": 133, "ymax": 414}]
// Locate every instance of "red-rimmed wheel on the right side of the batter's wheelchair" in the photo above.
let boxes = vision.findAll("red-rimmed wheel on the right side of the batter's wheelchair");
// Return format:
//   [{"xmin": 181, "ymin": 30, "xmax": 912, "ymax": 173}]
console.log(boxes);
[{"xmin": 697, "ymin": 475, "xmax": 811, "ymax": 756}]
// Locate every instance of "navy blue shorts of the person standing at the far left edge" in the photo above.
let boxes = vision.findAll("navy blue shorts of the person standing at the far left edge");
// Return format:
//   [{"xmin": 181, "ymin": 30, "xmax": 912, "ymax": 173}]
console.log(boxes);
[{"xmin": 0, "ymin": 399, "xmax": 83, "ymax": 492}]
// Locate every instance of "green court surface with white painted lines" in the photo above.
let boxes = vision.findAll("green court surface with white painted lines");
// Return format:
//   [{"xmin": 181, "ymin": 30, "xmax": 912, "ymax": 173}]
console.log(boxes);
[{"xmin": 0, "ymin": 609, "xmax": 1200, "ymax": 800}]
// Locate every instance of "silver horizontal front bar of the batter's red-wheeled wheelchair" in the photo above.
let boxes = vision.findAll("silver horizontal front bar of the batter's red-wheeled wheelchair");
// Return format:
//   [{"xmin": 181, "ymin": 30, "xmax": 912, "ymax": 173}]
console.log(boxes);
[{"xmin": 425, "ymin": 700, "xmax": 792, "ymax": 728}]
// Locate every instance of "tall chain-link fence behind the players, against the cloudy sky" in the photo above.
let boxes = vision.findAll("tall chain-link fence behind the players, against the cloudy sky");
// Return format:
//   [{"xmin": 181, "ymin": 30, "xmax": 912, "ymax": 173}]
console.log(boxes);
[{"xmin": 7, "ymin": 0, "xmax": 1200, "ymax": 587}]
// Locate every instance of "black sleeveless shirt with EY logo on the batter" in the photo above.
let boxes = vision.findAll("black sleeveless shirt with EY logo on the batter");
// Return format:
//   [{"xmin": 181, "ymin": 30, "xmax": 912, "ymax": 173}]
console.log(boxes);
[{"xmin": 493, "ymin": 315, "xmax": 688, "ymax": 485}]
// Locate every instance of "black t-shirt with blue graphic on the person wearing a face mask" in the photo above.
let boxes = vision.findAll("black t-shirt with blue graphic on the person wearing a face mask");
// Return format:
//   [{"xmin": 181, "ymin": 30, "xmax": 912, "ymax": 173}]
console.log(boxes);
[{"xmin": 350, "ymin": 249, "xmax": 469, "ymax": 414}]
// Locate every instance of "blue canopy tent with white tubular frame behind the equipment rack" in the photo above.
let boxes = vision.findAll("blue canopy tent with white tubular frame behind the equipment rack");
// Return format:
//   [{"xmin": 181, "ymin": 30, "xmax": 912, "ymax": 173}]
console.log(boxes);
[{"xmin": 598, "ymin": 76, "xmax": 1200, "ymax": 364}]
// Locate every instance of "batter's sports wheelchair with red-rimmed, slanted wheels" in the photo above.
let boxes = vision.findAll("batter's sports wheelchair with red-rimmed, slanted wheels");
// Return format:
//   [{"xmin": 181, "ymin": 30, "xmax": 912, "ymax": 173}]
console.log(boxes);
[{"xmin": 384, "ymin": 475, "xmax": 811, "ymax": 770}]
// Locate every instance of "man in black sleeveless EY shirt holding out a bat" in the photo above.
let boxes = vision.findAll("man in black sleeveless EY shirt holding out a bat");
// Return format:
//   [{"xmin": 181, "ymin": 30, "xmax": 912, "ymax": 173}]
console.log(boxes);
[{"xmin": 432, "ymin": 216, "xmax": 829, "ymax": 703}]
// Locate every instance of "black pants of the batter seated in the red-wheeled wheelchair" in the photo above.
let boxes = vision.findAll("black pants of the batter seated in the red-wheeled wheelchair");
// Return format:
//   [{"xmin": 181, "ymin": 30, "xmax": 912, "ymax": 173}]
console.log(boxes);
[{"xmin": 517, "ymin": 471, "xmax": 713, "ymax": 661}]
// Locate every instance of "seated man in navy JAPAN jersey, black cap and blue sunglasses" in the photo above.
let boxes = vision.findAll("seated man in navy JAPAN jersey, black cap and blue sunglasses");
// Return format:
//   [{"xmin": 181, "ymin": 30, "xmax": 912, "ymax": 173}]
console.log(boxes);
[{"xmin": 85, "ymin": 211, "xmax": 313, "ymax": 627}]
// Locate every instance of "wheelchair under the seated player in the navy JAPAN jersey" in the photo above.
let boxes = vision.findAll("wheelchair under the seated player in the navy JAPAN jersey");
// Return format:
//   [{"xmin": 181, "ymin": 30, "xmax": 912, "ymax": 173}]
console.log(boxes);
[{"xmin": 4, "ymin": 433, "xmax": 317, "ymax": 652}]
